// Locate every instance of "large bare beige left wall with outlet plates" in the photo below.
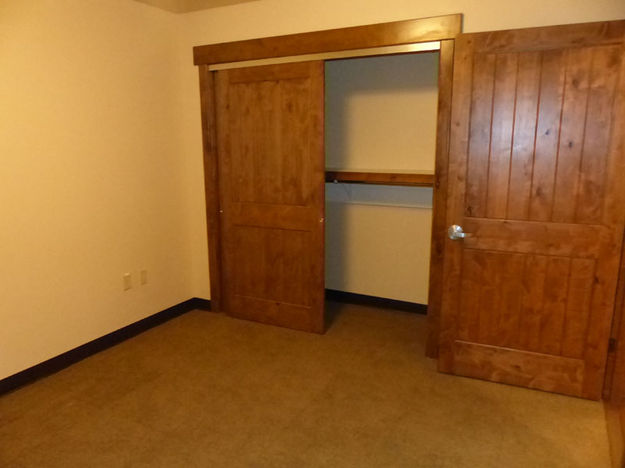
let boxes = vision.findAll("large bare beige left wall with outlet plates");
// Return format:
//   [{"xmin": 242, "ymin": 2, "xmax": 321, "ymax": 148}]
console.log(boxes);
[{"xmin": 0, "ymin": 0, "xmax": 194, "ymax": 378}]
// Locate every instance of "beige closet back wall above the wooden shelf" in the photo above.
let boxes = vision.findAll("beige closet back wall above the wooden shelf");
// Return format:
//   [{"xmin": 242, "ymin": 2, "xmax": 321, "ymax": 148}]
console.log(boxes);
[{"xmin": 325, "ymin": 52, "xmax": 439, "ymax": 171}]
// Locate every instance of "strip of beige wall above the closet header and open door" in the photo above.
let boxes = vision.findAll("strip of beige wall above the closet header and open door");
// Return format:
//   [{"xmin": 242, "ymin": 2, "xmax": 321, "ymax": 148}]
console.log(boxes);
[{"xmin": 185, "ymin": 0, "xmax": 625, "ymax": 45}]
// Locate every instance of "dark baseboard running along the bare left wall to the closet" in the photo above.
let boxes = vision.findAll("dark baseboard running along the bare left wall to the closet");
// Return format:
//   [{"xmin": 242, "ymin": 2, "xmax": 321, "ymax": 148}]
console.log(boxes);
[{"xmin": 0, "ymin": 297, "xmax": 211, "ymax": 395}]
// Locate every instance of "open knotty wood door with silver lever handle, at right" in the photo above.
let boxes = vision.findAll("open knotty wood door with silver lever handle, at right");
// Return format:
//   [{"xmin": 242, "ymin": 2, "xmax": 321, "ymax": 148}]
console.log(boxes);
[{"xmin": 439, "ymin": 21, "xmax": 625, "ymax": 399}]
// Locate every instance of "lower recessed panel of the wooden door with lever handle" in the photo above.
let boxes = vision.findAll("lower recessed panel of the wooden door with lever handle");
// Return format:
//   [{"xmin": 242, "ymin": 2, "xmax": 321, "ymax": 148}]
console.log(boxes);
[{"xmin": 457, "ymin": 248, "xmax": 595, "ymax": 359}]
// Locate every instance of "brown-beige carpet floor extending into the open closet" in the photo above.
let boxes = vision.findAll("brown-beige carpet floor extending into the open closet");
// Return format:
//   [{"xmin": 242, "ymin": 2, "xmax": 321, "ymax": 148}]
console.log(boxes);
[{"xmin": 0, "ymin": 304, "xmax": 609, "ymax": 468}]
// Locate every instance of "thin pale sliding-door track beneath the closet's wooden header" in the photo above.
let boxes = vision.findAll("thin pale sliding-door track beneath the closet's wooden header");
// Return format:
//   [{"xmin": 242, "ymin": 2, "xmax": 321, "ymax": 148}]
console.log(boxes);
[{"xmin": 208, "ymin": 41, "xmax": 441, "ymax": 71}]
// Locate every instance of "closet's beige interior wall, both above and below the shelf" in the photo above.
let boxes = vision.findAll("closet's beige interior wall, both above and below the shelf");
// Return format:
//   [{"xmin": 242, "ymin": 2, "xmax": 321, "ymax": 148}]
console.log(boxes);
[{"xmin": 325, "ymin": 52, "xmax": 439, "ymax": 304}]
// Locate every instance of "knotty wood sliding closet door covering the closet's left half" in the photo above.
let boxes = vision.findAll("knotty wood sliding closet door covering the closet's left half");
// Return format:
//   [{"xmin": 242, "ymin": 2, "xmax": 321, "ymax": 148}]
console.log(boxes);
[{"xmin": 216, "ymin": 62, "xmax": 325, "ymax": 333}]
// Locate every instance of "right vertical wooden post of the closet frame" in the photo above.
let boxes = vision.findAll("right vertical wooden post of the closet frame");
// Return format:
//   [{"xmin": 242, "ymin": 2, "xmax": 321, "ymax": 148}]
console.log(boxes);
[{"xmin": 425, "ymin": 40, "xmax": 454, "ymax": 358}]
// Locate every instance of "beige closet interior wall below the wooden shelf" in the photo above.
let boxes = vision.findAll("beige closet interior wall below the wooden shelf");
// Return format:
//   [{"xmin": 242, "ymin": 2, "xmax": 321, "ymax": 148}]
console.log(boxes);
[{"xmin": 326, "ymin": 184, "xmax": 432, "ymax": 304}]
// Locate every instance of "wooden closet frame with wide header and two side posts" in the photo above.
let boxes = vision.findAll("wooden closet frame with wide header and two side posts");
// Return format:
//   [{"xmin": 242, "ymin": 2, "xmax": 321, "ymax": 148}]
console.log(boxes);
[{"xmin": 193, "ymin": 14, "xmax": 462, "ymax": 330}]
